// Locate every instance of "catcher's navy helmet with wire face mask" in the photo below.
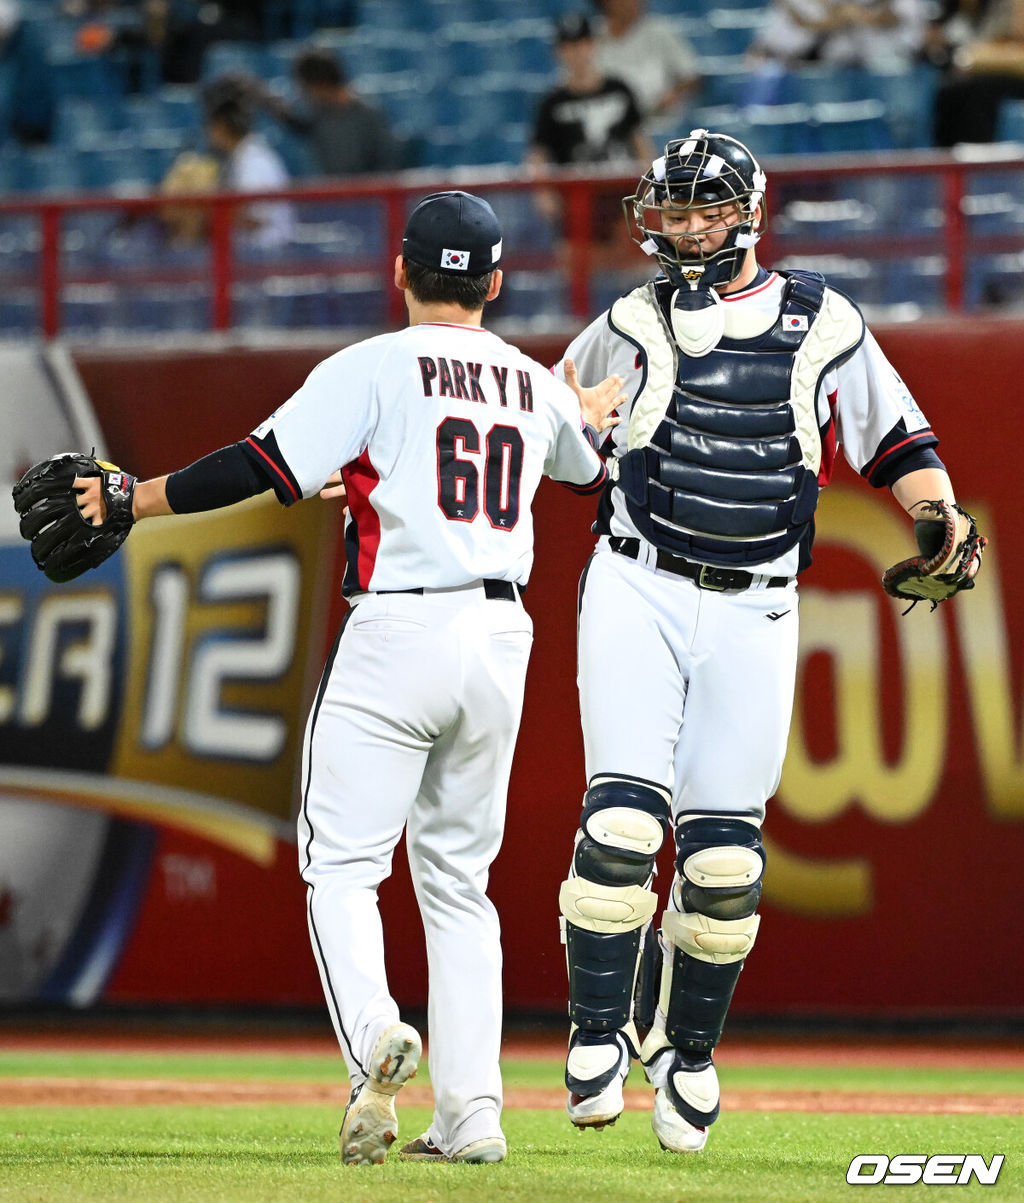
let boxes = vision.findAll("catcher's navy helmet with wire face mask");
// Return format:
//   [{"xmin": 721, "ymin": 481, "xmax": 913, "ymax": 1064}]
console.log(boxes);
[{"xmin": 622, "ymin": 130, "xmax": 766, "ymax": 289}]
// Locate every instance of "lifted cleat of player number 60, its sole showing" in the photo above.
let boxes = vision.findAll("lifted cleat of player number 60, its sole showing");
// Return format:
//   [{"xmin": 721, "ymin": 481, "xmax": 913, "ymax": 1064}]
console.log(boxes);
[{"xmin": 338, "ymin": 1024, "xmax": 422, "ymax": 1166}]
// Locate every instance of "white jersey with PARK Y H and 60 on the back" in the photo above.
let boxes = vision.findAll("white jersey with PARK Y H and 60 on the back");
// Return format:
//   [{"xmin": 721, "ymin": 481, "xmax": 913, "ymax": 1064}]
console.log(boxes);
[{"xmin": 253, "ymin": 322, "xmax": 604, "ymax": 594}]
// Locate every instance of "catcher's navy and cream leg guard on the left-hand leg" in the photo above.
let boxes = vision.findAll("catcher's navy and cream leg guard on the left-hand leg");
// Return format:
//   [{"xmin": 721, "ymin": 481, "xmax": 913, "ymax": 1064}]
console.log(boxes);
[{"xmin": 558, "ymin": 777, "xmax": 669, "ymax": 1031}]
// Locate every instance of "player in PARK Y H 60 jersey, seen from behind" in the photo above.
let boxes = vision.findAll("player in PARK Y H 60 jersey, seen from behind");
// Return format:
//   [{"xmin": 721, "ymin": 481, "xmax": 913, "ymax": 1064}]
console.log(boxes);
[{"xmin": 14, "ymin": 191, "xmax": 622, "ymax": 1165}]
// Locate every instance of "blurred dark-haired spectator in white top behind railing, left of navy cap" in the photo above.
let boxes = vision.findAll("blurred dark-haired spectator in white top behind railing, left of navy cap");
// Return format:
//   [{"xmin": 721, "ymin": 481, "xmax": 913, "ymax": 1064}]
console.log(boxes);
[{"xmin": 206, "ymin": 95, "xmax": 292, "ymax": 250}]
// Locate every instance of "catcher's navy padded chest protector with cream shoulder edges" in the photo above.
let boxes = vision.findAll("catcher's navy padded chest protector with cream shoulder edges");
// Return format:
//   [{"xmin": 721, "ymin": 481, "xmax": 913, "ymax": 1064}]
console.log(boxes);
[{"xmin": 609, "ymin": 272, "xmax": 864, "ymax": 565}]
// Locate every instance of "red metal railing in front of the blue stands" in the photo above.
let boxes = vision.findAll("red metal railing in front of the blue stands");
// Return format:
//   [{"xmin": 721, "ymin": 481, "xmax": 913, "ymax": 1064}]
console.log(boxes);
[{"xmin": 0, "ymin": 152, "xmax": 1024, "ymax": 337}]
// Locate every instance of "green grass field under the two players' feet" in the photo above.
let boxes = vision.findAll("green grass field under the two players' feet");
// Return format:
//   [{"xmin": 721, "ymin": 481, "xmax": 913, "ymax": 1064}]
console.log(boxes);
[{"xmin": 0, "ymin": 1048, "xmax": 1024, "ymax": 1203}]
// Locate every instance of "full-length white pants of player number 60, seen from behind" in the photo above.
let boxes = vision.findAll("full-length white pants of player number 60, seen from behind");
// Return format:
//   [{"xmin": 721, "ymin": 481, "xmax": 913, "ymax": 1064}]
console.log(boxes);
[{"xmin": 298, "ymin": 585, "xmax": 533, "ymax": 1154}]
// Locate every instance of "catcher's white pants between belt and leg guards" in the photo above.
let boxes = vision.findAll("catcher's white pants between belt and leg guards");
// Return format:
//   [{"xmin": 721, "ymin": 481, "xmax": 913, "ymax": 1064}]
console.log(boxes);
[{"xmin": 579, "ymin": 549, "xmax": 798, "ymax": 824}]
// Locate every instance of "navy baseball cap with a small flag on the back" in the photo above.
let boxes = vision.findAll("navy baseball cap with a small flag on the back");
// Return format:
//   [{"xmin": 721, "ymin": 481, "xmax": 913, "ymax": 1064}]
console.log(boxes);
[{"xmin": 402, "ymin": 192, "xmax": 502, "ymax": 275}]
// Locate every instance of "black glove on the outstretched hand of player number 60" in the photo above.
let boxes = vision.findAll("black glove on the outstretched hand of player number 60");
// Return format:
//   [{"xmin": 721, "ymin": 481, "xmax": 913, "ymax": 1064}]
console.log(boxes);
[{"xmin": 11, "ymin": 451, "xmax": 135, "ymax": 583}]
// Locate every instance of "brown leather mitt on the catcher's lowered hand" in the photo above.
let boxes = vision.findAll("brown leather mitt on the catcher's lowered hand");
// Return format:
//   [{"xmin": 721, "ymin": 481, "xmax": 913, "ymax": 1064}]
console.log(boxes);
[{"xmin": 882, "ymin": 500, "xmax": 988, "ymax": 610}]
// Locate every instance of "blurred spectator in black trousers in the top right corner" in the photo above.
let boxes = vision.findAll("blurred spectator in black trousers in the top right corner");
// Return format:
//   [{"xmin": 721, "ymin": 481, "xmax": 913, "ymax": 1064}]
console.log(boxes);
[{"xmin": 935, "ymin": 0, "xmax": 1024, "ymax": 147}]
